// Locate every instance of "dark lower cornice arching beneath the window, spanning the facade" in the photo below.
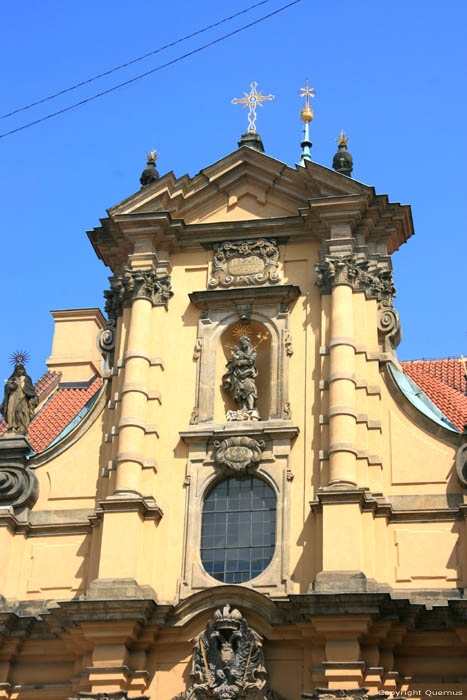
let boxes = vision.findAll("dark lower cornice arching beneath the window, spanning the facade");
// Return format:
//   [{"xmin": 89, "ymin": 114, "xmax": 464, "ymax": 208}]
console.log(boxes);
[{"xmin": 0, "ymin": 580, "xmax": 467, "ymax": 640}]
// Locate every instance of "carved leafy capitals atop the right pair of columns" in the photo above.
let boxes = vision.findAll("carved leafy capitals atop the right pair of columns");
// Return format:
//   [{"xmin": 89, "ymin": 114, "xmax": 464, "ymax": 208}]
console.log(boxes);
[{"xmin": 315, "ymin": 255, "xmax": 396, "ymax": 308}]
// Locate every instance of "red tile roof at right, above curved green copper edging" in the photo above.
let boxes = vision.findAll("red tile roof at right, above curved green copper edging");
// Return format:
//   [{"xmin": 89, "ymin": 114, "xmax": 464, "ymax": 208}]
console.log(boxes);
[{"xmin": 401, "ymin": 358, "xmax": 467, "ymax": 432}]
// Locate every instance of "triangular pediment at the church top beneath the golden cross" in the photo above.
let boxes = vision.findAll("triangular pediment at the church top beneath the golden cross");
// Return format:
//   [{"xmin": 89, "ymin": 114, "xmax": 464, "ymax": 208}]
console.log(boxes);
[{"xmin": 109, "ymin": 146, "xmax": 372, "ymax": 224}]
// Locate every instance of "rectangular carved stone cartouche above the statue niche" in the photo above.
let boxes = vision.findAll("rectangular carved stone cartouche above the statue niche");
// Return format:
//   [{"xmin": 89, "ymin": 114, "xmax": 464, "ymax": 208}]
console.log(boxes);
[{"xmin": 208, "ymin": 238, "xmax": 280, "ymax": 289}]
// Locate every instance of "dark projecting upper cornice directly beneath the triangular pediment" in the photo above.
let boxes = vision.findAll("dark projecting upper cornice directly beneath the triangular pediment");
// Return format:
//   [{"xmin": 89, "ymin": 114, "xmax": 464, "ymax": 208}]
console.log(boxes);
[{"xmin": 88, "ymin": 183, "xmax": 413, "ymax": 270}]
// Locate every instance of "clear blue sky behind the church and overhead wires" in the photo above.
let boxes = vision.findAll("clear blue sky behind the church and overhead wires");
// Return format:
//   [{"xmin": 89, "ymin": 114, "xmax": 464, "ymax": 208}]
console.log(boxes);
[{"xmin": 0, "ymin": 0, "xmax": 467, "ymax": 379}]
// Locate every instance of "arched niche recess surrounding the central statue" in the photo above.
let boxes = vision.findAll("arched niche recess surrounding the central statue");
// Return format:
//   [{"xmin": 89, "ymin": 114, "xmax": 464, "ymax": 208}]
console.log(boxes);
[{"xmin": 214, "ymin": 320, "xmax": 273, "ymax": 423}]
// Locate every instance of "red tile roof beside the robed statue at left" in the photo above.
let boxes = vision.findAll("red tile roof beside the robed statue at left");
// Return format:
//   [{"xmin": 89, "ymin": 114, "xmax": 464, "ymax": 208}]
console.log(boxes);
[{"xmin": 0, "ymin": 371, "xmax": 102, "ymax": 452}]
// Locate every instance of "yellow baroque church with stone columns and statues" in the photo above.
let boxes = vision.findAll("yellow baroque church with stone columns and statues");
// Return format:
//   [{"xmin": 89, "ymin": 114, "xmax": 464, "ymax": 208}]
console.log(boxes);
[{"xmin": 0, "ymin": 112, "xmax": 467, "ymax": 700}]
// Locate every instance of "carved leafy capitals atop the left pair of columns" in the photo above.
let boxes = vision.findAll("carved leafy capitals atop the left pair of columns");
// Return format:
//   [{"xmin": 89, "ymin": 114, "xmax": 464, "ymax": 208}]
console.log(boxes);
[{"xmin": 104, "ymin": 270, "xmax": 173, "ymax": 319}]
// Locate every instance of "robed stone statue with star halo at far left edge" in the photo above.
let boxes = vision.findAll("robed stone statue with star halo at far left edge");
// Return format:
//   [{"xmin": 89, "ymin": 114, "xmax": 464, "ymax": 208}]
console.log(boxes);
[{"xmin": 0, "ymin": 362, "xmax": 39, "ymax": 435}]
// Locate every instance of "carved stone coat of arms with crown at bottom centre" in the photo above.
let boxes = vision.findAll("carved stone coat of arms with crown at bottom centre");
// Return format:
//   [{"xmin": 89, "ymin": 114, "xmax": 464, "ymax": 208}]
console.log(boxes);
[{"xmin": 174, "ymin": 604, "xmax": 277, "ymax": 700}]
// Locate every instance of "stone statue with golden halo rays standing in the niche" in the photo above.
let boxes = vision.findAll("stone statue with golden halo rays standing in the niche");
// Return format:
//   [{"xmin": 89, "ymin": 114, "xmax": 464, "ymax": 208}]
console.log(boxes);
[{"xmin": 222, "ymin": 335, "xmax": 259, "ymax": 421}]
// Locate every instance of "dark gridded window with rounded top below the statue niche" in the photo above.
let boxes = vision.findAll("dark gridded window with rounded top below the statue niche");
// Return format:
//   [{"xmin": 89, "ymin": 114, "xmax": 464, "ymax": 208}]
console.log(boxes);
[{"xmin": 201, "ymin": 476, "xmax": 276, "ymax": 583}]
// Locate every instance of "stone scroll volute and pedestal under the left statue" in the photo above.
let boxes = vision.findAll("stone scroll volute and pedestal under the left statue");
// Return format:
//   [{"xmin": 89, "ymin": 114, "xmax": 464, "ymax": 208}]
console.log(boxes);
[{"xmin": 0, "ymin": 433, "xmax": 39, "ymax": 512}]
